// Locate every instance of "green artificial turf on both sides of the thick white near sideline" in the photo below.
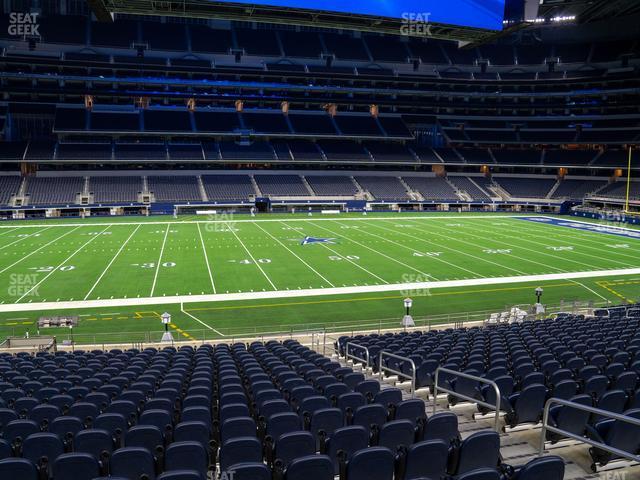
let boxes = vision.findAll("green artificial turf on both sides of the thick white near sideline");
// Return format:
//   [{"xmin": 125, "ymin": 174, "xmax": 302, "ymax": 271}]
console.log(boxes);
[{"xmin": 0, "ymin": 214, "xmax": 640, "ymax": 343}]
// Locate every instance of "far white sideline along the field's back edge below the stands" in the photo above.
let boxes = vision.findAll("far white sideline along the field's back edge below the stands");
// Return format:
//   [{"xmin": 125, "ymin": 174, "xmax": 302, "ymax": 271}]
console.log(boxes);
[{"xmin": 0, "ymin": 214, "xmax": 516, "ymax": 232}]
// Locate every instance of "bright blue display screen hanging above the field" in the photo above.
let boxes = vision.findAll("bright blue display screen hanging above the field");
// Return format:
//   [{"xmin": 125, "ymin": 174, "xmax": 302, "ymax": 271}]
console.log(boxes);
[{"xmin": 216, "ymin": 0, "xmax": 505, "ymax": 30}]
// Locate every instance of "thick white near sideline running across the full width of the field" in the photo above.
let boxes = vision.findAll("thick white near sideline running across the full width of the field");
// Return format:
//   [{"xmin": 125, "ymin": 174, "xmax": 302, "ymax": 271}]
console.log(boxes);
[{"xmin": 0, "ymin": 268, "xmax": 640, "ymax": 313}]
